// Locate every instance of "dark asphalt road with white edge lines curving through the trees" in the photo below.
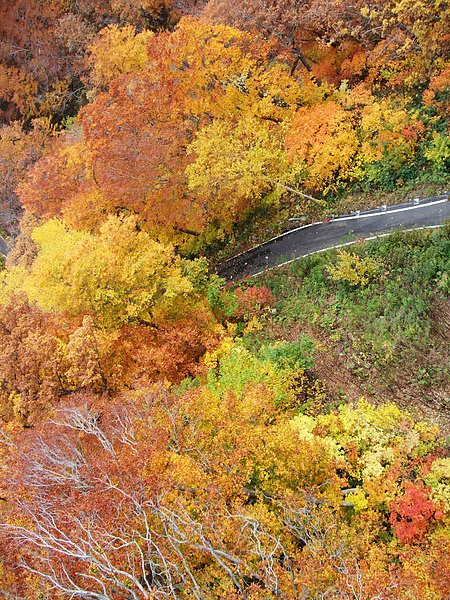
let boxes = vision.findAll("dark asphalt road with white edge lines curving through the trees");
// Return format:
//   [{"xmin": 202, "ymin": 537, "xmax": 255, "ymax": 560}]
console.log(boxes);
[{"xmin": 216, "ymin": 192, "xmax": 450, "ymax": 281}]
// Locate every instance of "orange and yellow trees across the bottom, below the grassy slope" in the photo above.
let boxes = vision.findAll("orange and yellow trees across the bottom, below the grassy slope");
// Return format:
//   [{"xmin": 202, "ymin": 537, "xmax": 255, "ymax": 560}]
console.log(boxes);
[{"xmin": 1, "ymin": 358, "xmax": 448, "ymax": 599}]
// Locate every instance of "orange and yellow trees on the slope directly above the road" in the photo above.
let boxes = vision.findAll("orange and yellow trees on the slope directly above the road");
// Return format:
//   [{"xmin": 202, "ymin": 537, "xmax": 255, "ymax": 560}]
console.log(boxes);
[{"xmin": 4, "ymin": 2, "xmax": 449, "ymax": 241}]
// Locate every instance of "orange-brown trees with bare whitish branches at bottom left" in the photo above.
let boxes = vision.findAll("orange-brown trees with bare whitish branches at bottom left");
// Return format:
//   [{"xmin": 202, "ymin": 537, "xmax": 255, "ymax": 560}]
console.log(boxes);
[{"xmin": 0, "ymin": 395, "xmax": 398, "ymax": 600}]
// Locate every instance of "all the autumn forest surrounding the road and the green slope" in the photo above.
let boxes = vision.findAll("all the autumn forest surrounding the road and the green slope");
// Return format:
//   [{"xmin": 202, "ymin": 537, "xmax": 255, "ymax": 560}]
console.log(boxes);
[{"xmin": 0, "ymin": 0, "xmax": 450, "ymax": 600}]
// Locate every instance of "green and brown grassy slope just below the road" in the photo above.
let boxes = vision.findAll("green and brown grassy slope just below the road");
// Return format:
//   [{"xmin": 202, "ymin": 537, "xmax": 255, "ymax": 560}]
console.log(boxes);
[{"xmin": 244, "ymin": 225, "xmax": 450, "ymax": 435}]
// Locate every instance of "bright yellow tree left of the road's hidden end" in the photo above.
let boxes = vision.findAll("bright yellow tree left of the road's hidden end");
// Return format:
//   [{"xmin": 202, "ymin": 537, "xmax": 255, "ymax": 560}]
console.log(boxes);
[{"xmin": 18, "ymin": 216, "xmax": 194, "ymax": 328}]
